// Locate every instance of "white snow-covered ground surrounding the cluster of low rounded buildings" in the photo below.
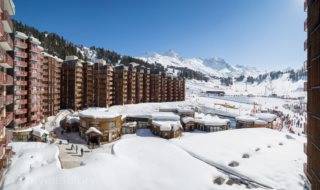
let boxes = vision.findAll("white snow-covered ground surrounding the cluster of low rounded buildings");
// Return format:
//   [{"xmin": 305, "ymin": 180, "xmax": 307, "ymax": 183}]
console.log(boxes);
[{"xmin": 4, "ymin": 80, "xmax": 306, "ymax": 190}]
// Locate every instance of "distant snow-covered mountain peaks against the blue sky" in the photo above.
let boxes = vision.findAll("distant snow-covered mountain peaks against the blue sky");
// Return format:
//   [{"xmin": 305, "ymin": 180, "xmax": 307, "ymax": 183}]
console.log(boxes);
[{"xmin": 138, "ymin": 50, "xmax": 261, "ymax": 77}]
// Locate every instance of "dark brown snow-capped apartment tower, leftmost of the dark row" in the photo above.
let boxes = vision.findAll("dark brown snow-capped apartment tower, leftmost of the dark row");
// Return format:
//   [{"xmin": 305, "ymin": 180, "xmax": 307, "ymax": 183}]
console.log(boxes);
[{"xmin": 60, "ymin": 56, "xmax": 83, "ymax": 110}]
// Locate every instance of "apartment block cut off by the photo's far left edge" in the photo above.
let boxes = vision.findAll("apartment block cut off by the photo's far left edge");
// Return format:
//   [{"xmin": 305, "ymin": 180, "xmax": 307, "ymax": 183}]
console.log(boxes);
[{"xmin": 0, "ymin": 0, "xmax": 15, "ymax": 183}]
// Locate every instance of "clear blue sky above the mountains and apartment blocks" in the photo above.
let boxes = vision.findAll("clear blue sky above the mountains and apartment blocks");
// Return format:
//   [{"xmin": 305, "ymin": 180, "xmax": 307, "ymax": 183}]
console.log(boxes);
[{"xmin": 14, "ymin": 0, "xmax": 306, "ymax": 70}]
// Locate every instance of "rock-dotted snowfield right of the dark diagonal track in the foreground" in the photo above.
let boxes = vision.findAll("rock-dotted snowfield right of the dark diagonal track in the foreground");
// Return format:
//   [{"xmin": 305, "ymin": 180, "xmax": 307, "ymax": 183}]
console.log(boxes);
[{"xmin": 172, "ymin": 128, "xmax": 306, "ymax": 190}]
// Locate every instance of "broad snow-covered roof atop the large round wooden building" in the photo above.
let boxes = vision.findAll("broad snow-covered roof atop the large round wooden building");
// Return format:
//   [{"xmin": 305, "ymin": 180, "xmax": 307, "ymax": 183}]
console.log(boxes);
[{"xmin": 79, "ymin": 108, "xmax": 121, "ymax": 119}]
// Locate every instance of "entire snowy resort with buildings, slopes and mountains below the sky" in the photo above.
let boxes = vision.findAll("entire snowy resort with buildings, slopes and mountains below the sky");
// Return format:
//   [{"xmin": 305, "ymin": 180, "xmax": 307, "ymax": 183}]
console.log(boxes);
[{"xmin": 0, "ymin": 0, "xmax": 320, "ymax": 190}]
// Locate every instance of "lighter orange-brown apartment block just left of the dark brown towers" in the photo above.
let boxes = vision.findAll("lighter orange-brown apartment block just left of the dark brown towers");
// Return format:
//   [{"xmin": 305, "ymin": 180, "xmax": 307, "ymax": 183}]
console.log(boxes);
[{"xmin": 42, "ymin": 52, "xmax": 63, "ymax": 117}]
